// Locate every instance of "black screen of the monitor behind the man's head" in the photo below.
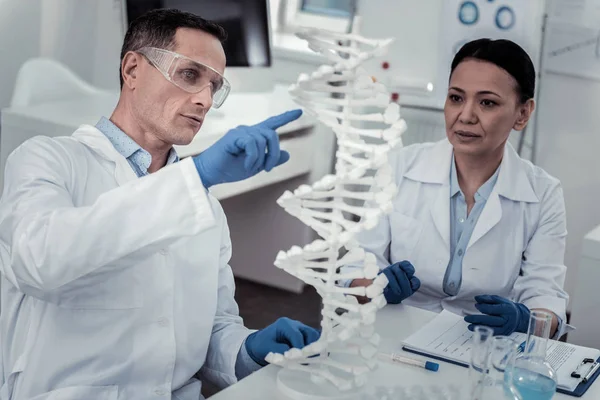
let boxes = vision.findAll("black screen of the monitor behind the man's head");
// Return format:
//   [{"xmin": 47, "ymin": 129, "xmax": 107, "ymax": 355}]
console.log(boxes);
[{"xmin": 126, "ymin": 0, "xmax": 271, "ymax": 67}]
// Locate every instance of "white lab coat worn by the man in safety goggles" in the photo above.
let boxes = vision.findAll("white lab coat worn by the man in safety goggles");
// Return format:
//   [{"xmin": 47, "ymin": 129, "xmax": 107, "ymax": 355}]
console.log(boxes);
[{"xmin": 0, "ymin": 126, "xmax": 250, "ymax": 400}]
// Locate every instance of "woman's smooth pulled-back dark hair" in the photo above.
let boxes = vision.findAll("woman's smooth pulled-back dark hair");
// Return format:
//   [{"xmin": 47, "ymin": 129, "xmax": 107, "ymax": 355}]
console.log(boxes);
[{"xmin": 450, "ymin": 39, "xmax": 535, "ymax": 103}]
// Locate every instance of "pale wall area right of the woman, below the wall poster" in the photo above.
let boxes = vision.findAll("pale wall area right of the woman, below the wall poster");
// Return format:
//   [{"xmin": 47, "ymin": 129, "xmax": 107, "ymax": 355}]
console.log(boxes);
[{"xmin": 537, "ymin": 74, "xmax": 600, "ymax": 297}]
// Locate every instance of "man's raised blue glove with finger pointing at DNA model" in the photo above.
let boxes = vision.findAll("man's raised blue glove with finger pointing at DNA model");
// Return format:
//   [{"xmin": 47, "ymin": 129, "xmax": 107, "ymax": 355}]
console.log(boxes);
[{"xmin": 193, "ymin": 110, "xmax": 302, "ymax": 189}]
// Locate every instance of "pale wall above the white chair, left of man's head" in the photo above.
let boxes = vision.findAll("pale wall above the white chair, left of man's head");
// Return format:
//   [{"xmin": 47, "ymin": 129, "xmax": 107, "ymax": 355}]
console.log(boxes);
[{"xmin": 0, "ymin": 0, "xmax": 123, "ymax": 109}]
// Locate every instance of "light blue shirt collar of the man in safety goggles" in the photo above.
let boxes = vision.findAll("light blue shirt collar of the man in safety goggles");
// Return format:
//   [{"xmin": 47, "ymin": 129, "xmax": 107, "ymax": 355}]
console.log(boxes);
[{"xmin": 96, "ymin": 117, "xmax": 179, "ymax": 177}]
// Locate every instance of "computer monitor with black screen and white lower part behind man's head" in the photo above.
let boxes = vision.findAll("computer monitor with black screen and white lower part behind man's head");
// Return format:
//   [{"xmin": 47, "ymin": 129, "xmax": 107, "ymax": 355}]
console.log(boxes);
[{"xmin": 124, "ymin": 0, "xmax": 274, "ymax": 93}]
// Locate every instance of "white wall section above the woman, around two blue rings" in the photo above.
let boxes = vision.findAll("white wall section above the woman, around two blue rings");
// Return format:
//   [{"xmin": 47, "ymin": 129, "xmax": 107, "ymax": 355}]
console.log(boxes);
[{"xmin": 357, "ymin": 0, "xmax": 545, "ymax": 108}]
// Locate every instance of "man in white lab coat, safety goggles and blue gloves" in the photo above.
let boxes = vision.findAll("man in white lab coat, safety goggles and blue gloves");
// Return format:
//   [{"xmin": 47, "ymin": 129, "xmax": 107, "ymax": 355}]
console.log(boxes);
[{"xmin": 0, "ymin": 10, "xmax": 319, "ymax": 400}]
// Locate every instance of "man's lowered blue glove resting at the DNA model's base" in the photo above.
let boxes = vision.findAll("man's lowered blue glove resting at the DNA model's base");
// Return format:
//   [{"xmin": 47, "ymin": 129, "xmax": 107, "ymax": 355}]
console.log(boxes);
[{"xmin": 246, "ymin": 317, "xmax": 321, "ymax": 366}]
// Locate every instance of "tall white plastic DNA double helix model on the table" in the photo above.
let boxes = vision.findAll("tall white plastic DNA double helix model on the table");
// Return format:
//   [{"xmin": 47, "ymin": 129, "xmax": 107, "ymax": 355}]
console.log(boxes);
[{"xmin": 267, "ymin": 21, "xmax": 406, "ymax": 398}]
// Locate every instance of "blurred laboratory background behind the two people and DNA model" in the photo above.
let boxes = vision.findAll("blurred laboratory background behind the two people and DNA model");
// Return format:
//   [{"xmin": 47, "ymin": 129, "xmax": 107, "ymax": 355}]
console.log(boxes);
[{"xmin": 0, "ymin": 0, "xmax": 600, "ymax": 398}]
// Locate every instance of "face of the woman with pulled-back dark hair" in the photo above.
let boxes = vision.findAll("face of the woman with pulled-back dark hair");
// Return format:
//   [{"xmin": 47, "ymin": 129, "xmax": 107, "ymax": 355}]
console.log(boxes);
[{"xmin": 444, "ymin": 59, "xmax": 534, "ymax": 157}]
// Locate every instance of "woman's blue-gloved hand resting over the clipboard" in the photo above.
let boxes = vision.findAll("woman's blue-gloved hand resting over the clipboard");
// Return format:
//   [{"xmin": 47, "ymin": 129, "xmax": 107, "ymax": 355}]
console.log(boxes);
[{"xmin": 465, "ymin": 294, "xmax": 531, "ymax": 335}]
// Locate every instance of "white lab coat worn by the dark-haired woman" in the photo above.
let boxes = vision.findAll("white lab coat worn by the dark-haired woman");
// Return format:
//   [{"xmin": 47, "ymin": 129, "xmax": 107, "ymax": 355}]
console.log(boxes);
[{"xmin": 346, "ymin": 139, "xmax": 568, "ymax": 325}]
